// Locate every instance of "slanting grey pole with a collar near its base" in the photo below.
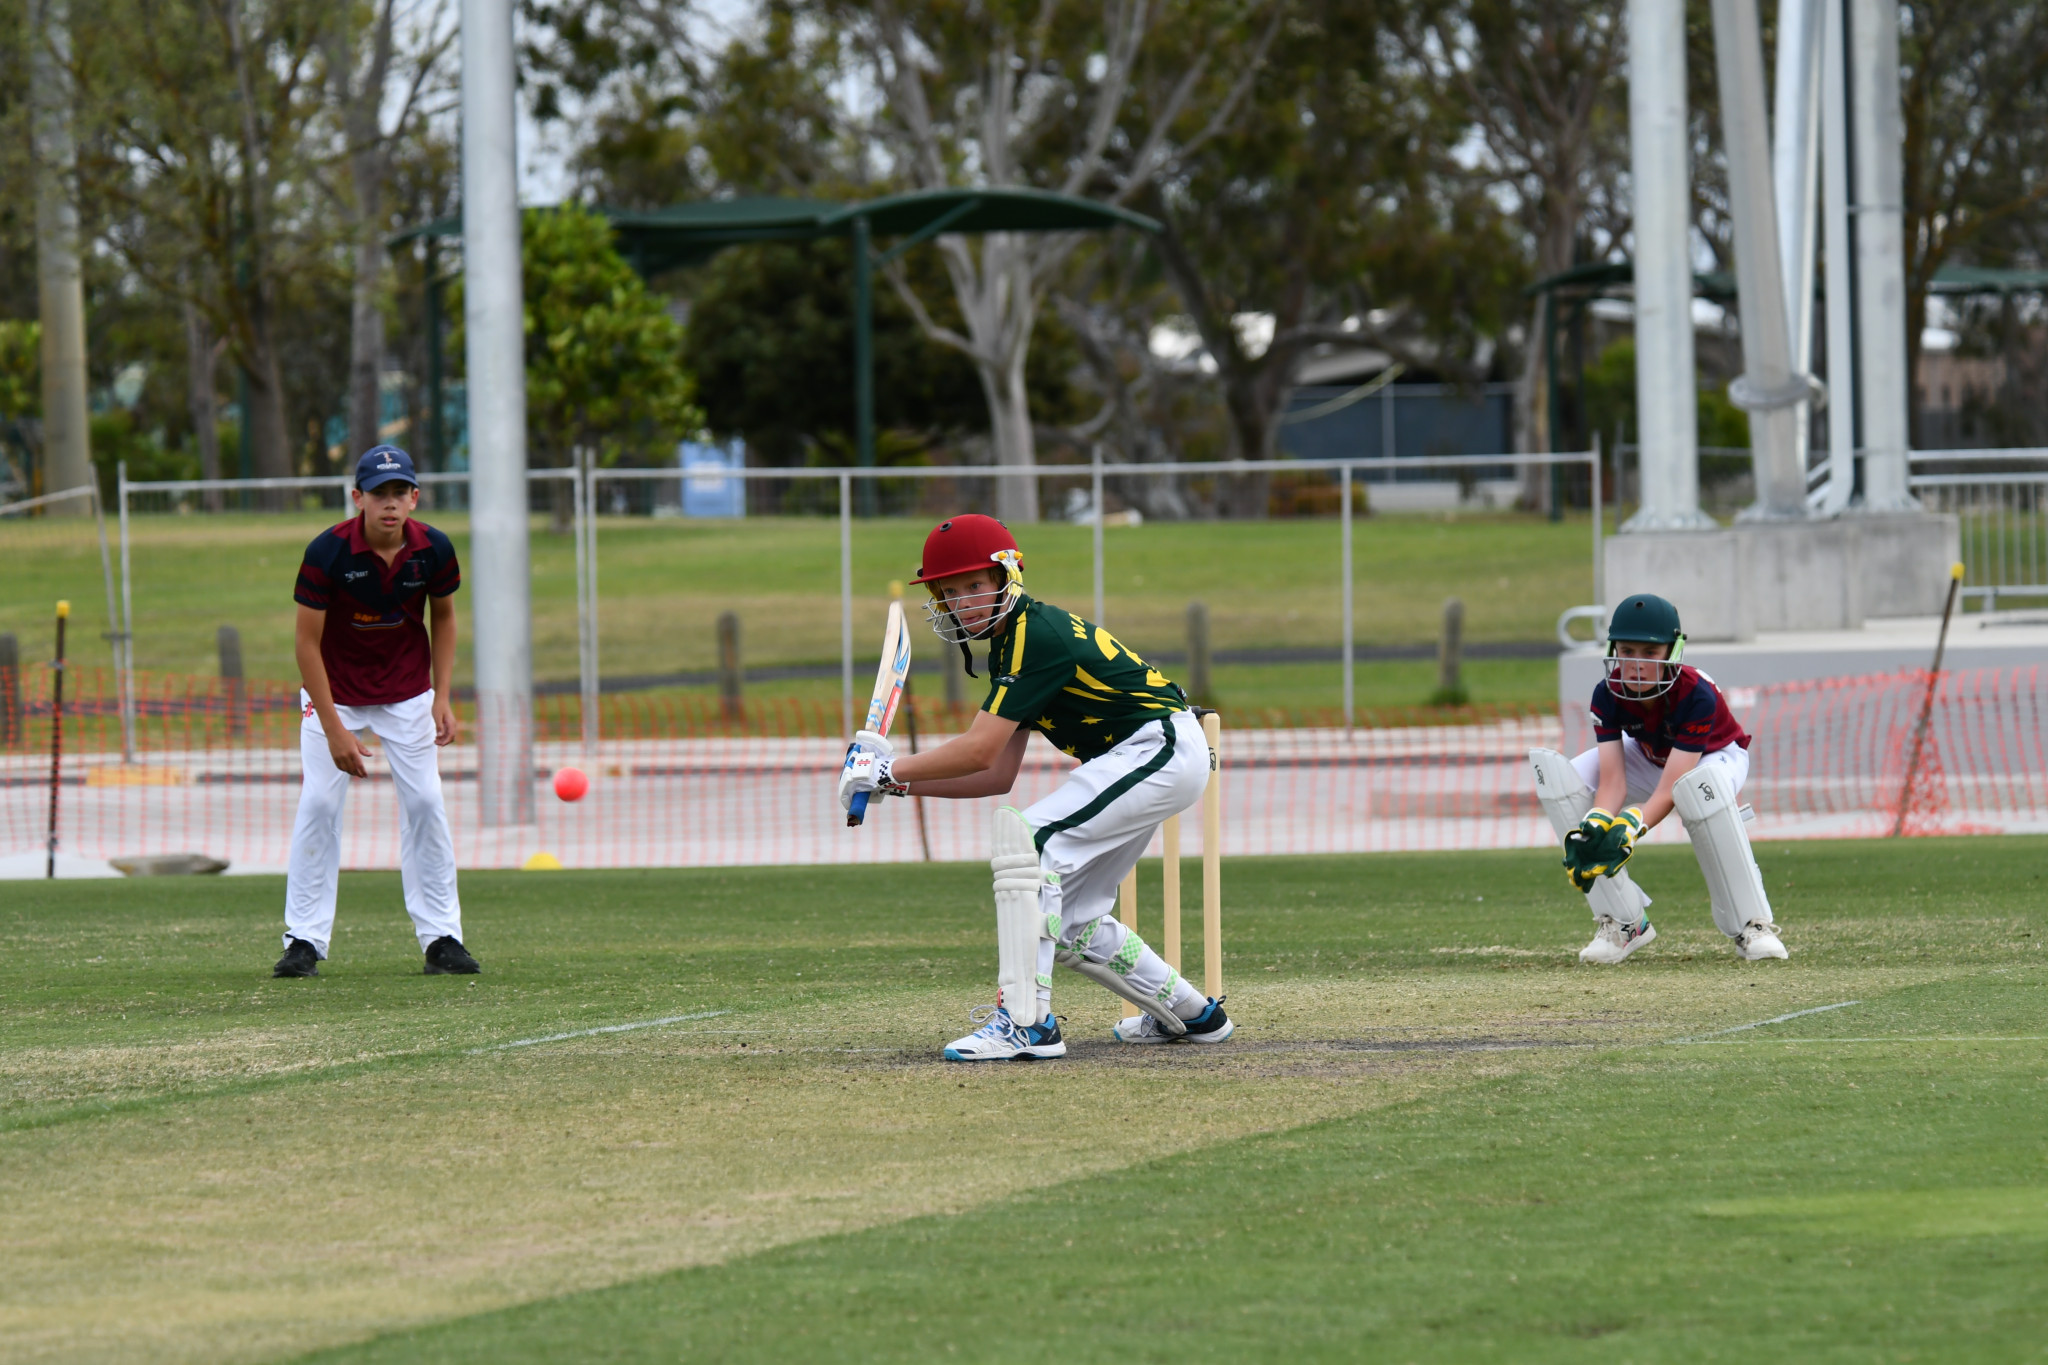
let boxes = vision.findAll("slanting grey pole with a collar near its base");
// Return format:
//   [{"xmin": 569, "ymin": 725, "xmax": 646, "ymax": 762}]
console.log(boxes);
[{"xmin": 1712, "ymin": 0, "xmax": 1808, "ymax": 520}]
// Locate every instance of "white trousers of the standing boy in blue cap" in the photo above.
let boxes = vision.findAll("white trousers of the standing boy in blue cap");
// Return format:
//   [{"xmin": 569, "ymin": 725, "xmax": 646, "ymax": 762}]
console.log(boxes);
[{"xmin": 285, "ymin": 690, "xmax": 463, "ymax": 958}]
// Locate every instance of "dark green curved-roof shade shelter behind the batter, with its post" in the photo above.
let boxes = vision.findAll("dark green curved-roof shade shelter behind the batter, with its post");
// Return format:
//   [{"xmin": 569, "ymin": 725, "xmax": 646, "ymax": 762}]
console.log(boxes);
[{"xmin": 389, "ymin": 188, "xmax": 1159, "ymax": 493}]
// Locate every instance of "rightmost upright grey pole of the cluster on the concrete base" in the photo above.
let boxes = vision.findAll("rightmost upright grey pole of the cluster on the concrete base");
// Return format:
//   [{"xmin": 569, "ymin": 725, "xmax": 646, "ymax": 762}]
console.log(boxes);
[{"xmin": 1849, "ymin": 0, "xmax": 1919, "ymax": 512}]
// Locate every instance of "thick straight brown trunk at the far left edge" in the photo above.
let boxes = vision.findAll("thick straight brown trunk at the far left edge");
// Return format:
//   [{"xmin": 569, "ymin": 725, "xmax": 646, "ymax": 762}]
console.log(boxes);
[{"xmin": 29, "ymin": 0, "xmax": 92, "ymax": 516}]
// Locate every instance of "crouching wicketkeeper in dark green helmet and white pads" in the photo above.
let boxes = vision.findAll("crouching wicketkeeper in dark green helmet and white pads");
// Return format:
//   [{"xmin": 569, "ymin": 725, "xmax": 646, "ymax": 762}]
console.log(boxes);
[{"xmin": 1530, "ymin": 593, "xmax": 1786, "ymax": 964}]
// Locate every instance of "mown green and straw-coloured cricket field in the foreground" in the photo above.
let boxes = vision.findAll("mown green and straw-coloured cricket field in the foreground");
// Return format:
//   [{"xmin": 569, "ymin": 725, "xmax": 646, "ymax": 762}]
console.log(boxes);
[{"xmin": 0, "ymin": 839, "xmax": 2048, "ymax": 1365}]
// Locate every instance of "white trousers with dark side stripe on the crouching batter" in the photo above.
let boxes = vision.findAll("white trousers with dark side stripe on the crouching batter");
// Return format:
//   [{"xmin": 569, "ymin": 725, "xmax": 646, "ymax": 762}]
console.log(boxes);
[{"xmin": 1024, "ymin": 710, "xmax": 1208, "ymax": 941}]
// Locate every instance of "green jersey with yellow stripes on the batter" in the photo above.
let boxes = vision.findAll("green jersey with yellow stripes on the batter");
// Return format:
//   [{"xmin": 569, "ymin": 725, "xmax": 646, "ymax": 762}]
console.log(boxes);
[{"xmin": 981, "ymin": 596, "xmax": 1188, "ymax": 763}]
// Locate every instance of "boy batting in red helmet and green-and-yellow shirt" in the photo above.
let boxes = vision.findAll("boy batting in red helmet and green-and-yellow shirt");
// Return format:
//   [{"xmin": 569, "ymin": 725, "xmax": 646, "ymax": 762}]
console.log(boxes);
[{"xmin": 840, "ymin": 516, "xmax": 1235, "ymax": 1062}]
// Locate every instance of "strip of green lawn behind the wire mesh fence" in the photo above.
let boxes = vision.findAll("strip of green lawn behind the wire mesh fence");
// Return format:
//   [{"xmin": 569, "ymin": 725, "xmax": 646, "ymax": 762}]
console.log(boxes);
[{"xmin": 0, "ymin": 512, "xmax": 1593, "ymax": 706}]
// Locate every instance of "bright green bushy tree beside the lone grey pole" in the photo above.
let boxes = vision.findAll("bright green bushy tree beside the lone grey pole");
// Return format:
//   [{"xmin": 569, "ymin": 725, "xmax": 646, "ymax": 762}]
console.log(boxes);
[{"xmin": 449, "ymin": 205, "xmax": 702, "ymax": 485}]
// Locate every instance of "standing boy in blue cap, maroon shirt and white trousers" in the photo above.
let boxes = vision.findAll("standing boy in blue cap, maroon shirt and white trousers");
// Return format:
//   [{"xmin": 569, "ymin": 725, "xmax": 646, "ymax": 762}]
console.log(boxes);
[{"xmin": 272, "ymin": 446, "xmax": 477, "ymax": 976}]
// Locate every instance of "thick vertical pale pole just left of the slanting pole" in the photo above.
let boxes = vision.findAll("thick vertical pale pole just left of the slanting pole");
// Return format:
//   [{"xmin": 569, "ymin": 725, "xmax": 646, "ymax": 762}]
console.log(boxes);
[{"xmin": 1613, "ymin": 0, "xmax": 1714, "ymax": 532}]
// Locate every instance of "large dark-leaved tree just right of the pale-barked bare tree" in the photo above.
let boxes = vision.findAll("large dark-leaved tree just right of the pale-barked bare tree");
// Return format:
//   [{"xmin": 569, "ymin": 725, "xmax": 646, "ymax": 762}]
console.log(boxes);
[{"xmin": 1130, "ymin": 0, "xmax": 1522, "ymax": 516}]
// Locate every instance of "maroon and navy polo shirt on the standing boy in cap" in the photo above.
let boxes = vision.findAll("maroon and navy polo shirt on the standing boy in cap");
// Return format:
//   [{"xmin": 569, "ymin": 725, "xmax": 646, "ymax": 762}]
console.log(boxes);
[{"xmin": 291, "ymin": 516, "xmax": 463, "ymax": 706}]
